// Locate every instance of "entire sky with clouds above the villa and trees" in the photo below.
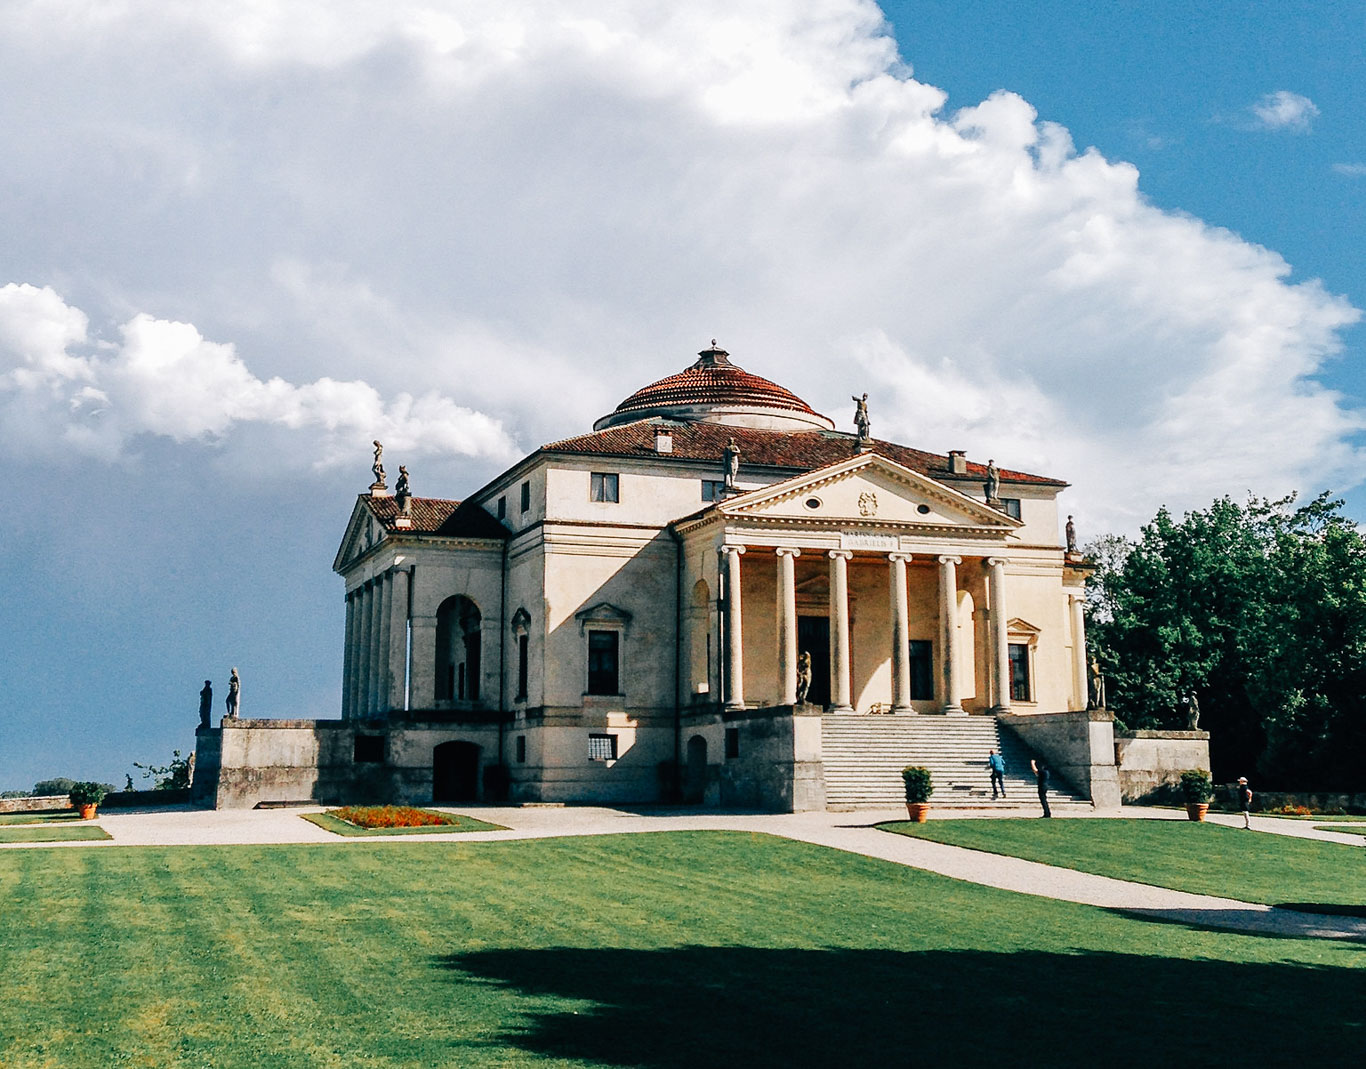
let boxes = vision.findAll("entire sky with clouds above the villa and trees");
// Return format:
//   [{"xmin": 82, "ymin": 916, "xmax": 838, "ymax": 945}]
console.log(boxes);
[{"xmin": 0, "ymin": 0, "xmax": 1366, "ymax": 788}]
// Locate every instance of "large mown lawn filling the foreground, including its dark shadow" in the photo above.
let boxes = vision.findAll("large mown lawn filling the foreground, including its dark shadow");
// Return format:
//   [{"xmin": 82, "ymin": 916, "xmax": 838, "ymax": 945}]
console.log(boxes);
[{"xmin": 0, "ymin": 822, "xmax": 1366, "ymax": 1069}]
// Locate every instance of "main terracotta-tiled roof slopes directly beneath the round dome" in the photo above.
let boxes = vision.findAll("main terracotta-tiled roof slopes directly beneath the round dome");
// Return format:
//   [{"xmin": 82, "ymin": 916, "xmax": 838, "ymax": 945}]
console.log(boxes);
[{"xmin": 538, "ymin": 419, "xmax": 1067, "ymax": 486}]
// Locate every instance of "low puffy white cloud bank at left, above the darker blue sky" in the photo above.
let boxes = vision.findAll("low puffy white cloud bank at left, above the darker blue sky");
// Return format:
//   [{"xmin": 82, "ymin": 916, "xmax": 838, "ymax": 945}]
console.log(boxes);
[{"xmin": 0, "ymin": 283, "xmax": 514, "ymax": 466}]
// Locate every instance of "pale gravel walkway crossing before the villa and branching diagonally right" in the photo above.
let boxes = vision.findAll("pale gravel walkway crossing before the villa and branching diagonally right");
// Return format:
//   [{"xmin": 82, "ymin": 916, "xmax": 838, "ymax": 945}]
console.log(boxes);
[{"xmin": 0, "ymin": 806, "xmax": 1366, "ymax": 942}]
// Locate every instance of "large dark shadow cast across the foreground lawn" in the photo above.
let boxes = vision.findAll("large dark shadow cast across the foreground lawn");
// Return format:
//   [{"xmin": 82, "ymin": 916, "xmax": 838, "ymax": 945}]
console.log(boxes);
[{"xmin": 437, "ymin": 946, "xmax": 1366, "ymax": 1069}]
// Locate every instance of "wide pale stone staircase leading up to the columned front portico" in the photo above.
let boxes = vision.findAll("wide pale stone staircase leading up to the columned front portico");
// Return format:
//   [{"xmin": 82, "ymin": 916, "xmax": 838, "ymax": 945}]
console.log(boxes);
[{"xmin": 821, "ymin": 714, "xmax": 1091, "ymax": 810}]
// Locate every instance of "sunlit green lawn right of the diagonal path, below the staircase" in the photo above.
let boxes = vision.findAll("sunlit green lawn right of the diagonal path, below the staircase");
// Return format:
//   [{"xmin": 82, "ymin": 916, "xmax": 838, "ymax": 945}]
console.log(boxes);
[{"xmin": 882, "ymin": 818, "xmax": 1366, "ymax": 912}]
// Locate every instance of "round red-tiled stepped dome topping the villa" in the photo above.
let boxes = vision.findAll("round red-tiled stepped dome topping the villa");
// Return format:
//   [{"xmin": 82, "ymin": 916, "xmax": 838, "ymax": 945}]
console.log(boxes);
[{"xmin": 593, "ymin": 341, "xmax": 835, "ymax": 430}]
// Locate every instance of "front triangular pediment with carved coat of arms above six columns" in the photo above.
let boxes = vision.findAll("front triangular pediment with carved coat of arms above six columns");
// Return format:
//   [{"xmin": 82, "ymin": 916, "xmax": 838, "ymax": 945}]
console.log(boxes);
[{"xmin": 719, "ymin": 453, "xmax": 1022, "ymax": 532}]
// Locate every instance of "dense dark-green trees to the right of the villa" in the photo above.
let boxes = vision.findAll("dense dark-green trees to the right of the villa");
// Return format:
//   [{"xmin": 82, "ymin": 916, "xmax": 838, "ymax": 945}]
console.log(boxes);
[{"xmin": 1087, "ymin": 494, "xmax": 1366, "ymax": 789}]
